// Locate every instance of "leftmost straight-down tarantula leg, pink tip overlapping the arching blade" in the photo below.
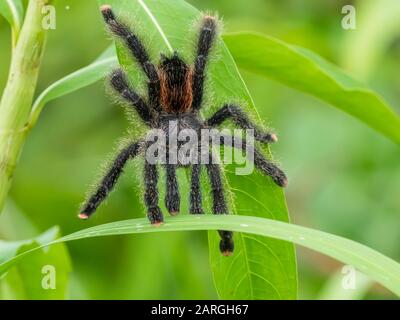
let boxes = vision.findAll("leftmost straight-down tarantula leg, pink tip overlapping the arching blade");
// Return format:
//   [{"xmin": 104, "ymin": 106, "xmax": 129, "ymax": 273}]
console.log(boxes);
[{"xmin": 144, "ymin": 159, "xmax": 164, "ymax": 225}]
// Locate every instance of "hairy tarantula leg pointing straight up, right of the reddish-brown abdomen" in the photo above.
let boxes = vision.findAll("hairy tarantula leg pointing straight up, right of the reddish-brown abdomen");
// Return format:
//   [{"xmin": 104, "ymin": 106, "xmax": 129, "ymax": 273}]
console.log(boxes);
[{"xmin": 192, "ymin": 16, "xmax": 217, "ymax": 111}]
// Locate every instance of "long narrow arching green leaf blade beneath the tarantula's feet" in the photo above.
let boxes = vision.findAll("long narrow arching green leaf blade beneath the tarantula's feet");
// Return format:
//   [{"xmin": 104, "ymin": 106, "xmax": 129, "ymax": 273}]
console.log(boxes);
[{"xmin": 0, "ymin": 215, "xmax": 400, "ymax": 296}]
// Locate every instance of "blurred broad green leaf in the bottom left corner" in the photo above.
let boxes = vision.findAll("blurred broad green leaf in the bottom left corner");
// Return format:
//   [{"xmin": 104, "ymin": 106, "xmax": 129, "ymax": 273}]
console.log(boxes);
[{"xmin": 0, "ymin": 227, "xmax": 71, "ymax": 300}]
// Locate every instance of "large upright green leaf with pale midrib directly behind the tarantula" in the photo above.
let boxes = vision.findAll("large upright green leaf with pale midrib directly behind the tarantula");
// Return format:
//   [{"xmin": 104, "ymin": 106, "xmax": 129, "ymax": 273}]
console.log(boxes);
[{"xmin": 99, "ymin": 0, "xmax": 297, "ymax": 299}]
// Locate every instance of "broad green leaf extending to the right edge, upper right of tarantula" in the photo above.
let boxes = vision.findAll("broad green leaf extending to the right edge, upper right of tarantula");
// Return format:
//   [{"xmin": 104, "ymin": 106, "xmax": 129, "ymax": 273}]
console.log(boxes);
[{"xmin": 224, "ymin": 33, "xmax": 400, "ymax": 143}]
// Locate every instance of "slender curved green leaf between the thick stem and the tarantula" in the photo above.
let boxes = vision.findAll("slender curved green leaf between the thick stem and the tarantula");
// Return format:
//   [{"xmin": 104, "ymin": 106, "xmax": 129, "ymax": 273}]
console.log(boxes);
[{"xmin": 29, "ymin": 47, "xmax": 117, "ymax": 126}]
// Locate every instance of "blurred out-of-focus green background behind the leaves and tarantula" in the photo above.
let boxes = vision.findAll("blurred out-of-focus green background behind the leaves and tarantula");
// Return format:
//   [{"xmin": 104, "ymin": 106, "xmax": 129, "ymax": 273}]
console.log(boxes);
[{"xmin": 0, "ymin": 0, "xmax": 400, "ymax": 299}]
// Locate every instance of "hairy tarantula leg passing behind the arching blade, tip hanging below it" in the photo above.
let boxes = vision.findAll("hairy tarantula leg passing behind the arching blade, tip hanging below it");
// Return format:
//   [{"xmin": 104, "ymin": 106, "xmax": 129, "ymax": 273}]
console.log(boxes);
[{"xmin": 206, "ymin": 156, "xmax": 234, "ymax": 256}]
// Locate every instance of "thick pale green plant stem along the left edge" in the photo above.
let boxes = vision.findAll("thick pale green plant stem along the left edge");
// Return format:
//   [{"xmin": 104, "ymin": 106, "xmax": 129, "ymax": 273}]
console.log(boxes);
[{"xmin": 0, "ymin": 0, "xmax": 49, "ymax": 210}]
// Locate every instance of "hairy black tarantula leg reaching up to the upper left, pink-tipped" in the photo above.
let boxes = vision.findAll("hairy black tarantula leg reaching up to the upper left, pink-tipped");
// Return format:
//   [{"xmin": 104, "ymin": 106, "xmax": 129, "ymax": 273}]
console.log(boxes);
[{"xmin": 101, "ymin": 5, "xmax": 160, "ymax": 111}]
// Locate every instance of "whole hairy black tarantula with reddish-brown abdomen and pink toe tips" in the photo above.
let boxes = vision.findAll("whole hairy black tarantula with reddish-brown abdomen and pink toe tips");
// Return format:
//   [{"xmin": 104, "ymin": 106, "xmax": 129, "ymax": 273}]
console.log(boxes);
[{"xmin": 79, "ymin": 5, "xmax": 287, "ymax": 255}]
